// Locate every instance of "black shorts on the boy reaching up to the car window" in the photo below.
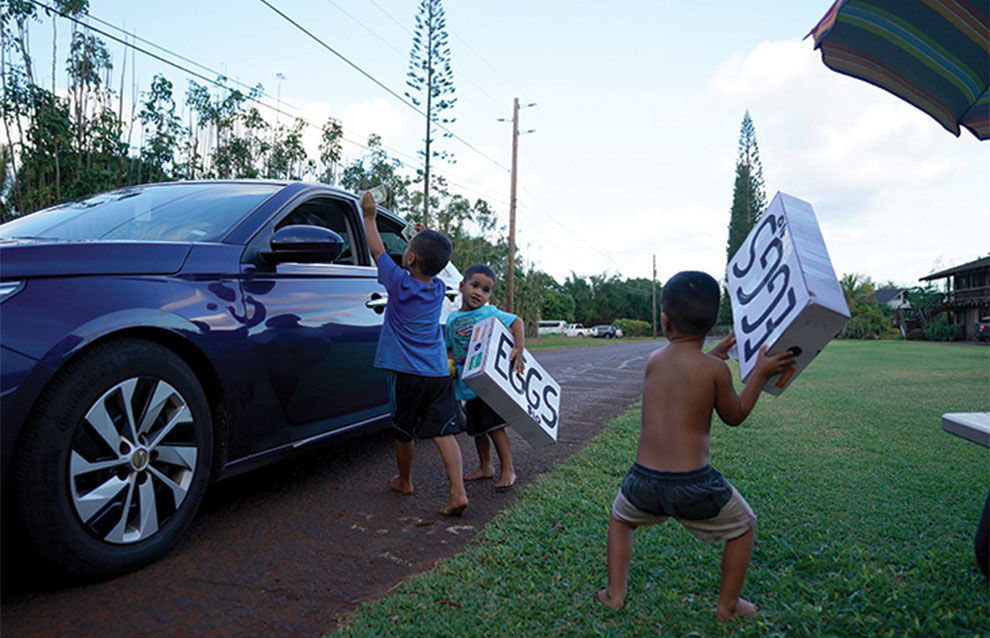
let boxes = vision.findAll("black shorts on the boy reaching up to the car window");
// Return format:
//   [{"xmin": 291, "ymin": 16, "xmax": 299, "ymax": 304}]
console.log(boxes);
[{"xmin": 388, "ymin": 372, "xmax": 461, "ymax": 443}]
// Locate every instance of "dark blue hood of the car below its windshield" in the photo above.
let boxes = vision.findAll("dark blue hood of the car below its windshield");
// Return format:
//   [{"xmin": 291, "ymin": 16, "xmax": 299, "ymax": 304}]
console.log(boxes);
[{"xmin": 0, "ymin": 239, "xmax": 192, "ymax": 279}]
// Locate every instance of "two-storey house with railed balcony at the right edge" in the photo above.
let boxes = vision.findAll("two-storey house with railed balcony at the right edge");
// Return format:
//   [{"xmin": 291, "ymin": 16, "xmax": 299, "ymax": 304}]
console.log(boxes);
[{"xmin": 919, "ymin": 256, "xmax": 990, "ymax": 340}]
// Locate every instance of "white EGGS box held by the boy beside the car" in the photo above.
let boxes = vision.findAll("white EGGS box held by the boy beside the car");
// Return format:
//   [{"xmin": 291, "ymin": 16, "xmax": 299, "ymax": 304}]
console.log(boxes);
[{"xmin": 463, "ymin": 317, "xmax": 560, "ymax": 447}]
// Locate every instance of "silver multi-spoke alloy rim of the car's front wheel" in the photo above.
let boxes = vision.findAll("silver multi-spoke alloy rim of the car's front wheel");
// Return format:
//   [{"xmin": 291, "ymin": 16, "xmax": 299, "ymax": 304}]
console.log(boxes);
[{"xmin": 68, "ymin": 377, "xmax": 199, "ymax": 545}]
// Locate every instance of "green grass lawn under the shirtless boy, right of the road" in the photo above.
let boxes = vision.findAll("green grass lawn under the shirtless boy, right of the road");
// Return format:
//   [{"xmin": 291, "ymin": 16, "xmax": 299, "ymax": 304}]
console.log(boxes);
[{"xmin": 337, "ymin": 341, "xmax": 990, "ymax": 638}]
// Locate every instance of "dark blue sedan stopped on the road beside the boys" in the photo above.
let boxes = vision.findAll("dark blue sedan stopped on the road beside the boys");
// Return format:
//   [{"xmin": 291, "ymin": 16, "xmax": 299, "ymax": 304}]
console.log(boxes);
[{"xmin": 0, "ymin": 181, "xmax": 460, "ymax": 576}]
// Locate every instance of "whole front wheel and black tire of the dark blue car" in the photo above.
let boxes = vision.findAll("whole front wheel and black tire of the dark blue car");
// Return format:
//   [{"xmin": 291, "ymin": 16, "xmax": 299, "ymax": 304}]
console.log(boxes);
[{"xmin": 12, "ymin": 338, "xmax": 213, "ymax": 578}]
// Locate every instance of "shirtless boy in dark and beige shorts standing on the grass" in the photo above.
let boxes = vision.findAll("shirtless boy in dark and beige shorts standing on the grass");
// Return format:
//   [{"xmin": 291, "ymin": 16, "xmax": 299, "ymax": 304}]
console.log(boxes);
[{"xmin": 597, "ymin": 271, "xmax": 794, "ymax": 620}]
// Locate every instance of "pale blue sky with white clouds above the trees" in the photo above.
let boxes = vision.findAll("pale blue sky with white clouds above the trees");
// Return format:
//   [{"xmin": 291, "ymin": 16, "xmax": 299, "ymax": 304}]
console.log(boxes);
[{"xmin": 17, "ymin": 0, "xmax": 990, "ymax": 286}]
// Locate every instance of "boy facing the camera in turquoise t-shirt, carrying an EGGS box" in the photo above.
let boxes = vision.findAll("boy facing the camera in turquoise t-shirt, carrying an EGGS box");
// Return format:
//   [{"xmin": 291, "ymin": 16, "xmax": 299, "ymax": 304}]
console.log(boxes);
[{"xmin": 447, "ymin": 264, "xmax": 524, "ymax": 490}]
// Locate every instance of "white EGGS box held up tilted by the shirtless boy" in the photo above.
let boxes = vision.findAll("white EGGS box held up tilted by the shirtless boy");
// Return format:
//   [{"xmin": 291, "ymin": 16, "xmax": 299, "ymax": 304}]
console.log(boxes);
[{"xmin": 726, "ymin": 193, "xmax": 849, "ymax": 395}]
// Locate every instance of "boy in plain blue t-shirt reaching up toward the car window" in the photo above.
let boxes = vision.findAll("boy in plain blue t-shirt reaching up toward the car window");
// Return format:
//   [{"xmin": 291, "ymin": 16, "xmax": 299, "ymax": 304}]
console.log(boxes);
[{"xmin": 361, "ymin": 192, "xmax": 468, "ymax": 516}]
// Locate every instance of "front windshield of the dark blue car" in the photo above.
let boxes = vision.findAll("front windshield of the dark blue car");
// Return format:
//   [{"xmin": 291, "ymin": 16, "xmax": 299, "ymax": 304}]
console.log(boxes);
[{"xmin": 0, "ymin": 183, "xmax": 281, "ymax": 242}]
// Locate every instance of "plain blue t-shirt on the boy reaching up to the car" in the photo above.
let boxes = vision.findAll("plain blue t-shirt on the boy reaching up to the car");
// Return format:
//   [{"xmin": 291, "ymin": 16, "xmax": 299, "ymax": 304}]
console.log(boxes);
[{"xmin": 375, "ymin": 253, "xmax": 450, "ymax": 377}]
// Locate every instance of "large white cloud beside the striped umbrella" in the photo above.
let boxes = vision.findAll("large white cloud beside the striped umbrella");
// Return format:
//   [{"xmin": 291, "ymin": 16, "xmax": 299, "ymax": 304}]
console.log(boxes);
[{"xmin": 701, "ymin": 40, "xmax": 990, "ymax": 283}]
